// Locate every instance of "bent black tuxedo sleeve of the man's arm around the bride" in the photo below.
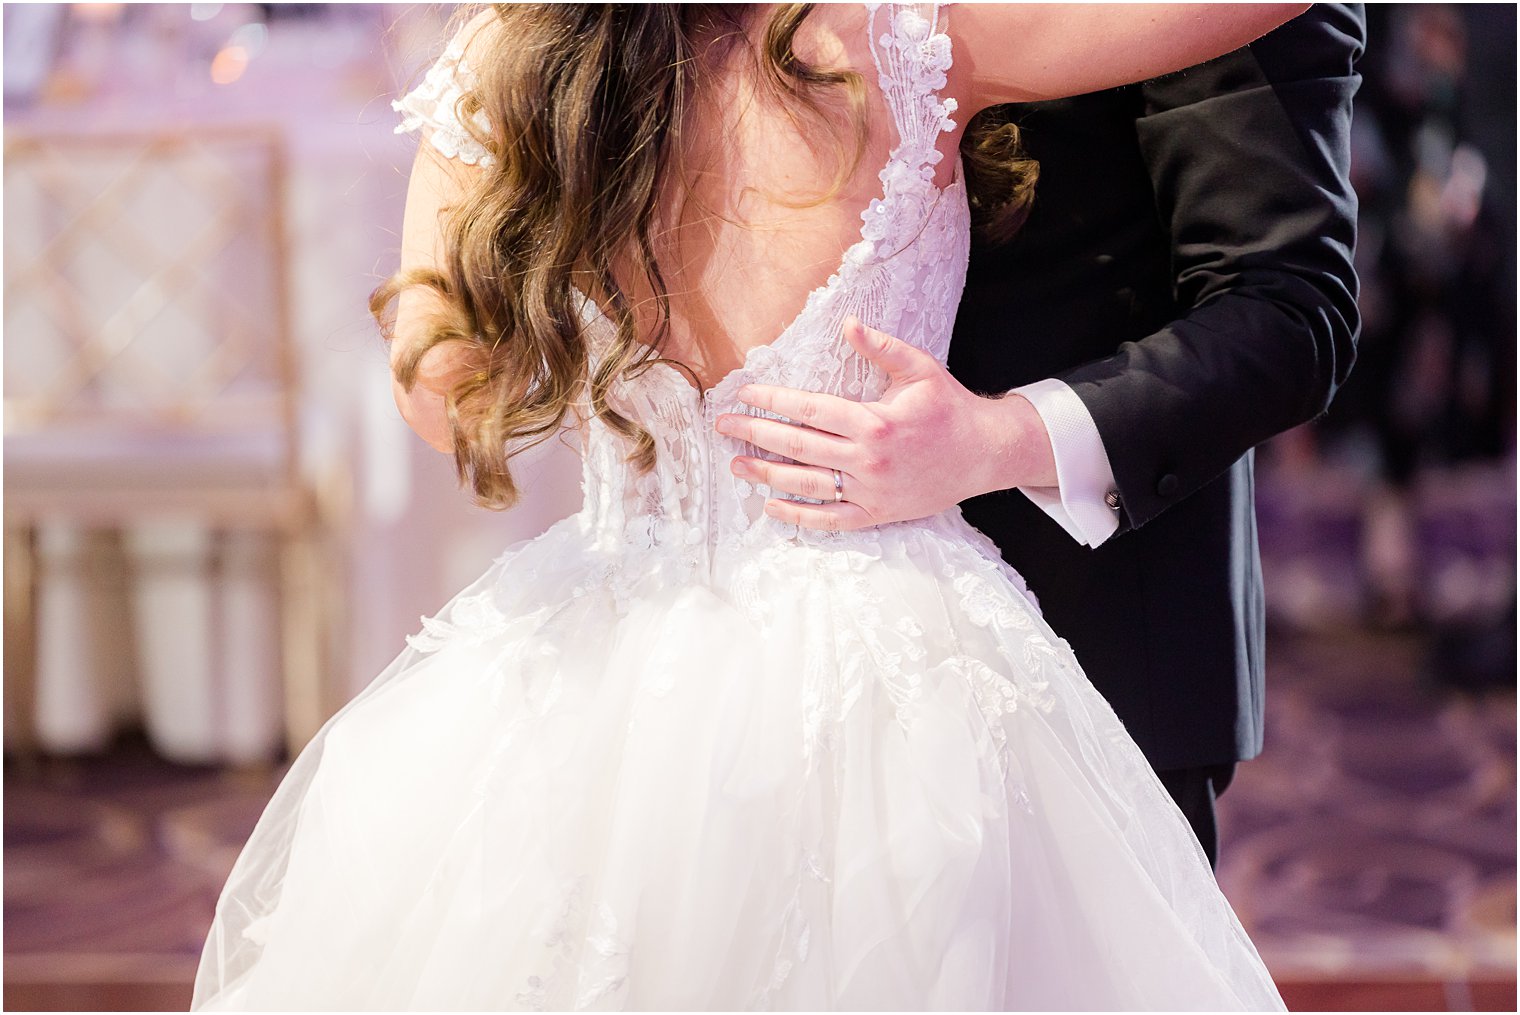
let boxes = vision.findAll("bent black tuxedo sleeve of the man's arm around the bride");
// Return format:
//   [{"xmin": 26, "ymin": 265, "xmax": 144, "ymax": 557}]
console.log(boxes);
[{"xmin": 1059, "ymin": 5, "xmax": 1365, "ymax": 530}]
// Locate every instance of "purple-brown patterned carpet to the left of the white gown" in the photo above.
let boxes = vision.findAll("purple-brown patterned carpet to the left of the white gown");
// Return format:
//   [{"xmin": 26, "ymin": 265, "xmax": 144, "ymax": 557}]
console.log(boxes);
[{"xmin": 5, "ymin": 741, "xmax": 264, "ymax": 1010}]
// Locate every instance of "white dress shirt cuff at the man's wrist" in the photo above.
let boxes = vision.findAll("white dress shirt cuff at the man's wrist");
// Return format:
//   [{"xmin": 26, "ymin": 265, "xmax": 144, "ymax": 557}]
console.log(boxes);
[{"xmin": 1011, "ymin": 377, "xmax": 1119, "ymax": 547}]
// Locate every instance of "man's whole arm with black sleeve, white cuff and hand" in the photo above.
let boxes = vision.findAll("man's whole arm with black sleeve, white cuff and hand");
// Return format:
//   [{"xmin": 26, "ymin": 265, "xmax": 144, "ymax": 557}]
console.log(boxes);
[{"xmin": 719, "ymin": 5, "xmax": 1365, "ymax": 534}]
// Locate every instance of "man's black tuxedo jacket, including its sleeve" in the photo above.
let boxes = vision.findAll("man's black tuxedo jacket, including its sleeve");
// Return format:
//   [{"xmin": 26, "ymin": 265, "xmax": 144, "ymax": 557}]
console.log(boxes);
[{"xmin": 950, "ymin": 5, "xmax": 1365, "ymax": 769}]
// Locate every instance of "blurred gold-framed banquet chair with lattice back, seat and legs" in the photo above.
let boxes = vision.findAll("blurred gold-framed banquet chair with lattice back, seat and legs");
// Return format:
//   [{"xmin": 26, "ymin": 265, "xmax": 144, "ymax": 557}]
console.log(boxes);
[{"xmin": 5, "ymin": 128, "xmax": 334, "ymax": 752}]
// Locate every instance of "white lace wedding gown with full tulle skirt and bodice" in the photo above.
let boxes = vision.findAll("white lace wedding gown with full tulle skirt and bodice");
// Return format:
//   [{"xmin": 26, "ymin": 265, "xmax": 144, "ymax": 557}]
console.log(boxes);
[{"xmin": 195, "ymin": 11, "xmax": 1281, "ymax": 1009}]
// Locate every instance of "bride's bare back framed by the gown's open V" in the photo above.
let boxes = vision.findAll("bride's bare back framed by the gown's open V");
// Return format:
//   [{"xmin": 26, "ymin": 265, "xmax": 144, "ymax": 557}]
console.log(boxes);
[{"xmin": 625, "ymin": 5, "xmax": 961, "ymax": 389}]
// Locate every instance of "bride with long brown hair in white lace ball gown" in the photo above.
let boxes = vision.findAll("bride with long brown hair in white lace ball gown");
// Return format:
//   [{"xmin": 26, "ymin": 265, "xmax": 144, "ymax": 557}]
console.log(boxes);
[{"xmin": 195, "ymin": 5, "xmax": 1303, "ymax": 1010}]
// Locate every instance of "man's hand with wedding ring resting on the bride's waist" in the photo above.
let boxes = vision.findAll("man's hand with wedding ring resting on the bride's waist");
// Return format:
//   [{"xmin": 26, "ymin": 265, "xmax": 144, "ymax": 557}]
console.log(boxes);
[{"xmin": 716, "ymin": 319, "xmax": 1056, "ymax": 532}]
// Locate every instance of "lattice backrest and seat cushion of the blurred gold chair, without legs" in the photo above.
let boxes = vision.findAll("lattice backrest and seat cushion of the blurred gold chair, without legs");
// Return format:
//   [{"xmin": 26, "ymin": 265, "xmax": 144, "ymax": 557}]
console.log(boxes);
[{"xmin": 5, "ymin": 128, "xmax": 299, "ymax": 522}]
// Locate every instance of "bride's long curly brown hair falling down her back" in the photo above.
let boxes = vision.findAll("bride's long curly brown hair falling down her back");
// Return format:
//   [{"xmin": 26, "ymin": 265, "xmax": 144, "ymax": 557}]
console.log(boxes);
[{"xmin": 369, "ymin": 3, "xmax": 1035, "ymax": 508}]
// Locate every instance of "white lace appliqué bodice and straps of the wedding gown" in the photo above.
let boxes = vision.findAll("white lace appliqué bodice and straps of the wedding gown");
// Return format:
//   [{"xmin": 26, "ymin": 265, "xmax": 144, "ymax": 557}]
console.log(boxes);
[{"xmin": 395, "ymin": 5, "xmax": 970, "ymax": 594}]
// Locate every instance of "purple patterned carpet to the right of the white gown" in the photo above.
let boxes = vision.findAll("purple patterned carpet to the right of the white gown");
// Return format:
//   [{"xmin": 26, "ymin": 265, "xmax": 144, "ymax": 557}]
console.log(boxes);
[{"xmin": 1219, "ymin": 635, "xmax": 1515, "ymax": 1007}]
